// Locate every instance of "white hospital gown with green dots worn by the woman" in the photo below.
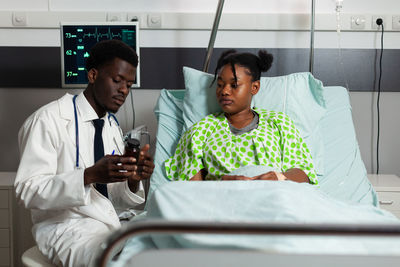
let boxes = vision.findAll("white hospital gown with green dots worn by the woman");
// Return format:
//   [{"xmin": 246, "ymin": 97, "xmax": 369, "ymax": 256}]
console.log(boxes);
[{"xmin": 165, "ymin": 109, "xmax": 318, "ymax": 184}]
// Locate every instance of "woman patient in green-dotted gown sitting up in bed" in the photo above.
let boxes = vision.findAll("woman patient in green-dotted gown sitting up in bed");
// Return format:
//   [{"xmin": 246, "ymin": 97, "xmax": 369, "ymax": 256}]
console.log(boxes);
[{"xmin": 165, "ymin": 50, "xmax": 318, "ymax": 184}]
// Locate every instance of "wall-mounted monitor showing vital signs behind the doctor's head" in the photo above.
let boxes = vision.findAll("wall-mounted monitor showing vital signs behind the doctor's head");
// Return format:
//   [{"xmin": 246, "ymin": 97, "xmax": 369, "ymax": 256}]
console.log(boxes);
[{"xmin": 60, "ymin": 22, "xmax": 140, "ymax": 88}]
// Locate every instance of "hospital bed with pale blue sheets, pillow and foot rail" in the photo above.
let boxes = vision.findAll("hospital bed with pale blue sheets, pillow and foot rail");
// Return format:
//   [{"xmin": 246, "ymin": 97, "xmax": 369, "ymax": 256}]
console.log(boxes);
[{"xmin": 93, "ymin": 72, "xmax": 400, "ymax": 266}]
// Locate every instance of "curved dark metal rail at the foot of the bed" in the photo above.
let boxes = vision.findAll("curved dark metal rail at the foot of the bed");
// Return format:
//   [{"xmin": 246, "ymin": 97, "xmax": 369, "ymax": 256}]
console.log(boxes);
[{"xmin": 96, "ymin": 220, "xmax": 400, "ymax": 266}]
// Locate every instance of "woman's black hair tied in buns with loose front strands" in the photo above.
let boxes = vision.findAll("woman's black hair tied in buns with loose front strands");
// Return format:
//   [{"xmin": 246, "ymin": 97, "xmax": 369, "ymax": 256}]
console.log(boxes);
[{"xmin": 213, "ymin": 49, "xmax": 274, "ymax": 83}]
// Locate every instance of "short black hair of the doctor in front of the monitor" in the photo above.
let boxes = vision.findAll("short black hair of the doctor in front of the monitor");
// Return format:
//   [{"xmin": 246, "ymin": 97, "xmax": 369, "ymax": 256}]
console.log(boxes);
[{"xmin": 86, "ymin": 39, "xmax": 139, "ymax": 71}]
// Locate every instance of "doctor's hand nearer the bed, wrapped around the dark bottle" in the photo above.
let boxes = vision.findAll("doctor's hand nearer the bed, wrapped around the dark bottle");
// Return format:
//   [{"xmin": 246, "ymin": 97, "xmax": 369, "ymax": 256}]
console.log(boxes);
[{"xmin": 128, "ymin": 144, "xmax": 154, "ymax": 192}]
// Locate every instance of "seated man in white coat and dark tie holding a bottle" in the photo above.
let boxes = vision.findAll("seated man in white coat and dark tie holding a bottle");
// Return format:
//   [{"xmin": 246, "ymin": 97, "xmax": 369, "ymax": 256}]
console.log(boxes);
[{"xmin": 15, "ymin": 40, "xmax": 154, "ymax": 266}]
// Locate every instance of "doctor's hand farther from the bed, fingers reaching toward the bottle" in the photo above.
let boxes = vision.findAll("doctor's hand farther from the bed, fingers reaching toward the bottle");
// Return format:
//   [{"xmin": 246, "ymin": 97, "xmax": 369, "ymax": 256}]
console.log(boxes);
[{"xmin": 84, "ymin": 155, "xmax": 137, "ymax": 185}]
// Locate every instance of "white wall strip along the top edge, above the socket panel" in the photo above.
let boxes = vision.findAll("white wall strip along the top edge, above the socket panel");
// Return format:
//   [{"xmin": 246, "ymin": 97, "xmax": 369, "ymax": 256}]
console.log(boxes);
[{"xmin": 0, "ymin": 0, "xmax": 400, "ymax": 13}]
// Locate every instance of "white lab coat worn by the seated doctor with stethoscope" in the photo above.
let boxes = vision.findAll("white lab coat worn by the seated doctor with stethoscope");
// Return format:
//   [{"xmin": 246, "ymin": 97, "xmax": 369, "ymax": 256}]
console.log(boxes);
[{"xmin": 15, "ymin": 93, "xmax": 145, "ymax": 266}]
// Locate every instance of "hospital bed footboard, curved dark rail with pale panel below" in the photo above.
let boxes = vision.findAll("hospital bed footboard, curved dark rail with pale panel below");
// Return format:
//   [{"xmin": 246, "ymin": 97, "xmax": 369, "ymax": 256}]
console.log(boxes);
[{"xmin": 96, "ymin": 221, "xmax": 400, "ymax": 267}]
